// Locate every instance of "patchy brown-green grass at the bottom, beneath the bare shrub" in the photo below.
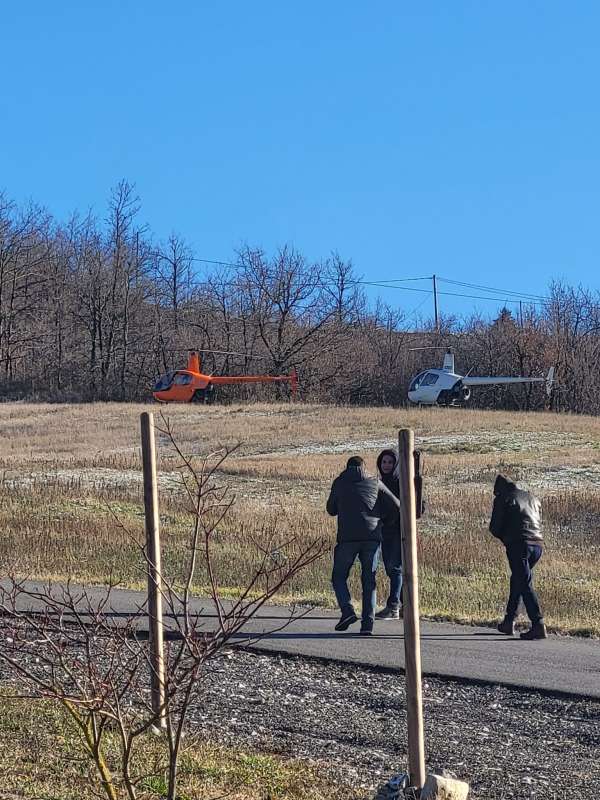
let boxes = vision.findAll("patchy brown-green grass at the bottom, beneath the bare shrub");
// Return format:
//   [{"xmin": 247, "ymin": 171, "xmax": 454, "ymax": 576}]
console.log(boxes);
[{"xmin": 0, "ymin": 701, "xmax": 364, "ymax": 800}]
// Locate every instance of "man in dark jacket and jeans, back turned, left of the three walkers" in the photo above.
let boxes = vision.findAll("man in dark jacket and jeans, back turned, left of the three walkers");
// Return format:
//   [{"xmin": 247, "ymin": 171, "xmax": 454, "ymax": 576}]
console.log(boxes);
[{"xmin": 327, "ymin": 456, "xmax": 399, "ymax": 636}]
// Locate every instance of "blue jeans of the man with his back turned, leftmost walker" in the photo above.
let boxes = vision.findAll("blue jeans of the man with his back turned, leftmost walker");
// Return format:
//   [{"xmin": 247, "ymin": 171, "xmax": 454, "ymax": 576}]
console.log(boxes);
[{"xmin": 331, "ymin": 542, "xmax": 380, "ymax": 623}]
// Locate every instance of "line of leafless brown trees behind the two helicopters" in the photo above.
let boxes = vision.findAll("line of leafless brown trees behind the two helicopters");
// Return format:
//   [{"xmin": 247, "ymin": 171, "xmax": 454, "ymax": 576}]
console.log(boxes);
[{"xmin": 0, "ymin": 181, "xmax": 600, "ymax": 414}]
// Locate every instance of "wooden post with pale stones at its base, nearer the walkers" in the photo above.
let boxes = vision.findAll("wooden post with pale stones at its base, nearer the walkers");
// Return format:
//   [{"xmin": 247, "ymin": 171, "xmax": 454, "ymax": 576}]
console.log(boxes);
[{"xmin": 398, "ymin": 429, "xmax": 425, "ymax": 789}]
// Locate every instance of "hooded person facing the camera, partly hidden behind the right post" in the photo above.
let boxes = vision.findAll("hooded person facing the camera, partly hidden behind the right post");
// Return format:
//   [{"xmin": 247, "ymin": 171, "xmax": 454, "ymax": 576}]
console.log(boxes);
[{"xmin": 375, "ymin": 447, "xmax": 402, "ymax": 620}]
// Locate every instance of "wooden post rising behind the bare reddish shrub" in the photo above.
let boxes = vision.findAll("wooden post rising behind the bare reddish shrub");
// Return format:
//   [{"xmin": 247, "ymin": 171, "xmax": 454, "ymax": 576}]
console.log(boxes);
[{"xmin": 141, "ymin": 411, "xmax": 167, "ymax": 728}]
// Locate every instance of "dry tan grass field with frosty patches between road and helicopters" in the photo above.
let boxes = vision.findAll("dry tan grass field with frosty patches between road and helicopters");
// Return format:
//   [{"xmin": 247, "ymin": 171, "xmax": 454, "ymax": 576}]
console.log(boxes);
[{"xmin": 0, "ymin": 404, "xmax": 600, "ymax": 635}]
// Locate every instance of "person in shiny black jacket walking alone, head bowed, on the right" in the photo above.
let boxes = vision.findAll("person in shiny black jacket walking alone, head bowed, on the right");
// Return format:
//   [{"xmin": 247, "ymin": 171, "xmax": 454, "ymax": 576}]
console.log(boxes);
[{"xmin": 490, "ymin": 475, "xmax": 546, "ymax": 639}]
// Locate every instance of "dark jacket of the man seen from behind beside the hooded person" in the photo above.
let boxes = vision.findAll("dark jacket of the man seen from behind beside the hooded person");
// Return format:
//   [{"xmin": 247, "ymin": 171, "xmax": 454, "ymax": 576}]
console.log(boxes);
[{"xmin": 327, "ymin": 467, "xmax": 398, "ymax": 543}]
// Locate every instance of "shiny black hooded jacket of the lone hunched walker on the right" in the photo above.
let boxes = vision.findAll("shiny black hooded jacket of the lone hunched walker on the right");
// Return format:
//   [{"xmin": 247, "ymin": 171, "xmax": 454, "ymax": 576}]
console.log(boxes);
[{"xmin": 490, "ymin": 475, "xmax": 543, "ymax": 547}]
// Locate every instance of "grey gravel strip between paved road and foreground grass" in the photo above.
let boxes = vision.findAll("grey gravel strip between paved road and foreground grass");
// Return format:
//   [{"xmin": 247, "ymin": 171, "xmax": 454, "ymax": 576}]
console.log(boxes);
[{"xmin": 192, "ymin": 648, "xmax": 600, "ymax": 800}]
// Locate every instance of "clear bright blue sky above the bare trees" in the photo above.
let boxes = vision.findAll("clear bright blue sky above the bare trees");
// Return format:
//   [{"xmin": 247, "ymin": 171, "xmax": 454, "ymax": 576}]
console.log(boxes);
[{"xmin": 0, "ymin": 0, "xmax": 600, "ymax": 322}]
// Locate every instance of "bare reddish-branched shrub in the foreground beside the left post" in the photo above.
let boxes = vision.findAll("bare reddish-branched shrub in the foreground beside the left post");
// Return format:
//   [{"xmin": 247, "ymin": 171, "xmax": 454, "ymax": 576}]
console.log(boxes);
[{"xmin": 0, "ymin": 432, "xmax": 328, "ymax": 800}]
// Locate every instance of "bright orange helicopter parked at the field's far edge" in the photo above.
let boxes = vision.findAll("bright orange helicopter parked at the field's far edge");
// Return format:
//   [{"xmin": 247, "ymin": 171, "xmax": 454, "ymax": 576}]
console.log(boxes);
[{"xmin": 153, "ymin": 350, "xmax": 298, "ymax": 403}]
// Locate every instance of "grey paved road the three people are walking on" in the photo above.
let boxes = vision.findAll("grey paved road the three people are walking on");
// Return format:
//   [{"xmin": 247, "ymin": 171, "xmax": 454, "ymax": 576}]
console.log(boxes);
[{"xmin": 0, "ymin": 583, "xmax": 600, "ymax": 700}]
